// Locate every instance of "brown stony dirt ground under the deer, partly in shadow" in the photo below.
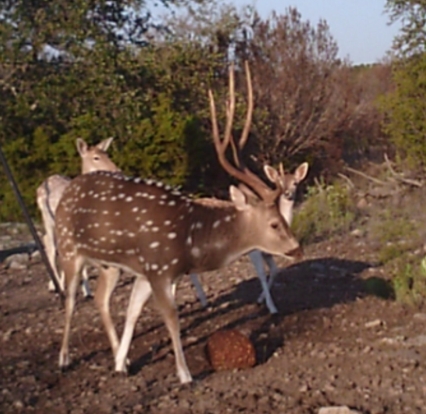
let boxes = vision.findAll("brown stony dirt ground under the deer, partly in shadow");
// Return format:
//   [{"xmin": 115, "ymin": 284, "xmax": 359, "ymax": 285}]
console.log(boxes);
[{"xmin": 0, "ymin": 182, "xmax": 426, "ymax": 414}]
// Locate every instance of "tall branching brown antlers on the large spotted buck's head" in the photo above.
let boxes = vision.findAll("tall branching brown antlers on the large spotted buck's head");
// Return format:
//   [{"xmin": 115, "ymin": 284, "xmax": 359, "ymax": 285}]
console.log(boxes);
[{"xmin": 209, "ymin": 62, "xmax": 276, "ymax": 199}]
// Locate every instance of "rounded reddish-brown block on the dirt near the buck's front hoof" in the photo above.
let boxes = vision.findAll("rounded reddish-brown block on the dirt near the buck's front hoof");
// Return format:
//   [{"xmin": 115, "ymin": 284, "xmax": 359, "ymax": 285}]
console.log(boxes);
[{"xmin": 207, "ymin": 329, "xmax": 256, "ymax": 371}]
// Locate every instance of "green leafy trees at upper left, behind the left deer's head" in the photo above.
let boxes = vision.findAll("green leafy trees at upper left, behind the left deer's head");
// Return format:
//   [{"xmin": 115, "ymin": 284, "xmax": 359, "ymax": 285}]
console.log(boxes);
[{"xmin": 0, "ymin": 0, "xmax": 215, "ymax": 219}]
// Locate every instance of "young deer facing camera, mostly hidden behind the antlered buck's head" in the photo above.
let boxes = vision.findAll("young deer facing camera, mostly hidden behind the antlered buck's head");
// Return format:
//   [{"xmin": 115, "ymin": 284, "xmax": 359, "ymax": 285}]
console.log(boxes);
[{"xmin": 190, "ymin": 162, "xmax": 309, "ymax": 314}]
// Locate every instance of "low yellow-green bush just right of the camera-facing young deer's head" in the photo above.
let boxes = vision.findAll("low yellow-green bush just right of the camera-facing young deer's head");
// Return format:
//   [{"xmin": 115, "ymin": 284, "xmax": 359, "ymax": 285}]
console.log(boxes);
[{"xmin": 293, "ymin": 182, "xmax": 357, "ymax": 243}]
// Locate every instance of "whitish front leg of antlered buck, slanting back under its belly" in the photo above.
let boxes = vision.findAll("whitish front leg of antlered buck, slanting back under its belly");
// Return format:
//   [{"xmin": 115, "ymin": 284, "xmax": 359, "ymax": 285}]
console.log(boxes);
[{"xmin": 115, "ymin": 275, "xmax": 152, "ymax": 372}]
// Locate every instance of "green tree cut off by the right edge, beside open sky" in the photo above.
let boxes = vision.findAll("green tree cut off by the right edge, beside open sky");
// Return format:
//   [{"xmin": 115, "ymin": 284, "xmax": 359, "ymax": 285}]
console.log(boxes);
[{"xmin": 382, "ymin": 0, "xmax": 426, "ymax": 166}]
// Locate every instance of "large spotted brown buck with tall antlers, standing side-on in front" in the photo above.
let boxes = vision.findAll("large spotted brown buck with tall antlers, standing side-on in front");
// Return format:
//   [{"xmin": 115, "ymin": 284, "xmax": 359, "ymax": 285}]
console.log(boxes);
[{"xmin": 55, "ymin": 65, "xmax": 302, "ymax": 383}]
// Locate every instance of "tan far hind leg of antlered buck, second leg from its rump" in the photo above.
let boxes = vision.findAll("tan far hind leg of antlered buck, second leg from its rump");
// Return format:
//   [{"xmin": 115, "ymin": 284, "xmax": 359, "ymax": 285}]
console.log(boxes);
[{"xmin": 95, "ymin": 267, "xmax": 120, "ymax": 357}]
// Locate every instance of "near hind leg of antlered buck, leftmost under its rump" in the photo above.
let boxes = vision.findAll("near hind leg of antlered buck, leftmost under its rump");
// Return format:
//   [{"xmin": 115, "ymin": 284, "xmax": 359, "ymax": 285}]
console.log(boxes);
[{"xmin": 59, "ymin": 257, "xmax": 82, "ymax": 368}]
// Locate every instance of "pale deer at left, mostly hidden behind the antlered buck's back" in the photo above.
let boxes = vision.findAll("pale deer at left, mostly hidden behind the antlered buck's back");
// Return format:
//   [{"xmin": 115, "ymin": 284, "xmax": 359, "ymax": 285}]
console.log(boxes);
[{"xmin": 37, "ymin": 138, "xmax": 119, "ymax": 297}]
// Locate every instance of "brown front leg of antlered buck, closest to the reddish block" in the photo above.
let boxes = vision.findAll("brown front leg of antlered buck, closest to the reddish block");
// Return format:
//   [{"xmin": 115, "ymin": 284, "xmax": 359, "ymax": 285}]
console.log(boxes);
[{"xmin": 153, "ymin": 279, "xmax": 192, "ymax": 384}]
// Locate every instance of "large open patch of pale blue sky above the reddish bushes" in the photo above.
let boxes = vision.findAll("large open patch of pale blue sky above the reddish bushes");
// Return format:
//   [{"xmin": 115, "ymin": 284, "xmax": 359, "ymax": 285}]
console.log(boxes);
[{"xmin": 230, "ymin": 0, "xmax": 399, "ymax": 64}]
